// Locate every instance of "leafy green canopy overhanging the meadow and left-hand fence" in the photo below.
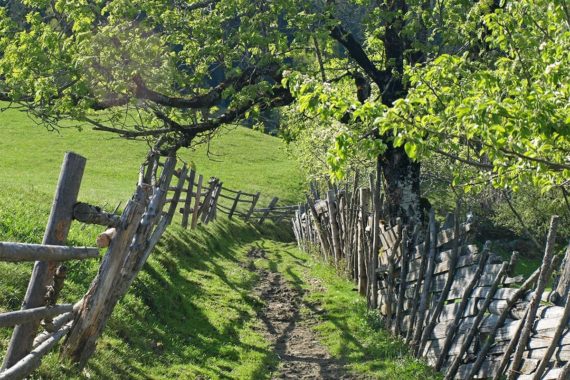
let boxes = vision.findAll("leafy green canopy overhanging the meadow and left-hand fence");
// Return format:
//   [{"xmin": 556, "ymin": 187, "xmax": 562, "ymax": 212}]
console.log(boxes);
[{"xmin": 0, "ymin": 0, "xmax": 320, "ymax": 153}]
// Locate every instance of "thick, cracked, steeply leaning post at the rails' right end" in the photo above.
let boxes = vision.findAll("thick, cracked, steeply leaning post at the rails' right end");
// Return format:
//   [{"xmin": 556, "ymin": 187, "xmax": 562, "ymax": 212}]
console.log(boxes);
[{"xmin": 63, "ymin": 157, "xmax": 176, "ymax": 368}]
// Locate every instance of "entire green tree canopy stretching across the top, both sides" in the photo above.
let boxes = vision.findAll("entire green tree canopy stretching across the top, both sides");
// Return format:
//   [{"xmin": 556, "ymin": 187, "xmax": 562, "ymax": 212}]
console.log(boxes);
[{"xmin": 0, "ymin": 0, "xmax": 570, "ymax": 190}]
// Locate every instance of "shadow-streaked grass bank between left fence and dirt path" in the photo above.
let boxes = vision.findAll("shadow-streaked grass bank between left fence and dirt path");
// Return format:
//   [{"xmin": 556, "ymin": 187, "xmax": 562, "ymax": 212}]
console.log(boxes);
[{"xmin": 77, "ymin": 221, "xmax": 288, "ymax": 378}]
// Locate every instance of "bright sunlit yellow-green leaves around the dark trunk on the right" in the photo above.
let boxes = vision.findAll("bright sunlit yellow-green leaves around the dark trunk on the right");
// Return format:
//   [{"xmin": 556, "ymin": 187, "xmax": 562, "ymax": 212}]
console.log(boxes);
[{"xmin": 286, "ymin": 0, "xmax": 570, "ymax": 190}]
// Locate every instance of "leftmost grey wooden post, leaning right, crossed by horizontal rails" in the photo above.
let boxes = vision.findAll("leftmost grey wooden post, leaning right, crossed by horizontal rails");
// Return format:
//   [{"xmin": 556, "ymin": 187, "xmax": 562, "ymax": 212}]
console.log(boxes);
[{"xmin": 2, "ymin": 152, "xmax": 86, "ymax": 369}]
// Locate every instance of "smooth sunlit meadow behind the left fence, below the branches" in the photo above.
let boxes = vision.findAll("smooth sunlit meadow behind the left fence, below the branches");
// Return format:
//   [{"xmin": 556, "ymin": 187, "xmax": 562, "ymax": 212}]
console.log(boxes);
[{"xmin": 0, "ymin": 104, "xmax": 302, "ymax": 208}]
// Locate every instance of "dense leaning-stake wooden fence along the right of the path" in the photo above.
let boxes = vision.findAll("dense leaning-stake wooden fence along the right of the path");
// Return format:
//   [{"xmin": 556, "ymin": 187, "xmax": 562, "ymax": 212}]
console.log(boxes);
[{"xmin": 292, "ymin": 183, "xmax": 570, "ymax": 380}]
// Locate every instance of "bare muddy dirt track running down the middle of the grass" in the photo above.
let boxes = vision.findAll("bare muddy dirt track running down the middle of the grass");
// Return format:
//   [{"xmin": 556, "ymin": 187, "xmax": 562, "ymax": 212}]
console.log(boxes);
[{"xmin": 249, "ymin": 249, "xmax": 358, "ymax": 379}]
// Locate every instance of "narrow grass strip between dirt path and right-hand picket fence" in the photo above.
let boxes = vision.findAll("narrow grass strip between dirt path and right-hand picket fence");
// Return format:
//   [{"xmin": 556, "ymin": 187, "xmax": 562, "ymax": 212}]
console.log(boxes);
[{"xmin": 250, "ymin": 239, "xmax": 443, "ymax": 380}]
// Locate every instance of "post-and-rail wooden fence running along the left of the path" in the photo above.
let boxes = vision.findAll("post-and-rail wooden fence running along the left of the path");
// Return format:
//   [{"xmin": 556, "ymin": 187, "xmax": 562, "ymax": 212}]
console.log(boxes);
[{"xmin": 0, "ymin": 153, "xmax": 290, "ymax": 380}]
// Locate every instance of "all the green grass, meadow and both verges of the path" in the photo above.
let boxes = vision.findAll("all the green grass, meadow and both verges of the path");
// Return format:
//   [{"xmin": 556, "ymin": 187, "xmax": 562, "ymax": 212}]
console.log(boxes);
[{"xmin": 0, "ymin": 107, "xmax": 434, "ymax": 379}]
